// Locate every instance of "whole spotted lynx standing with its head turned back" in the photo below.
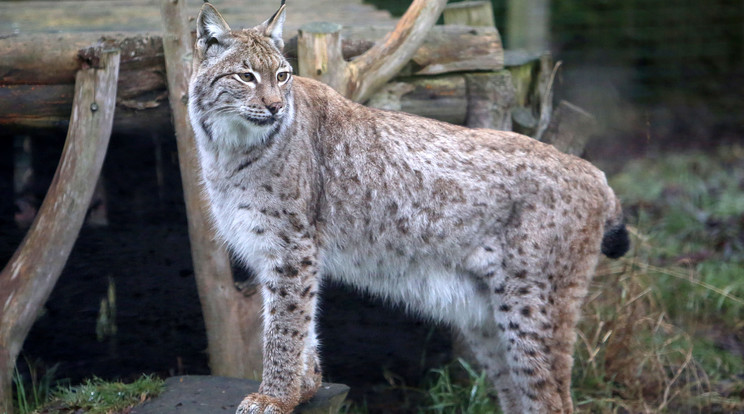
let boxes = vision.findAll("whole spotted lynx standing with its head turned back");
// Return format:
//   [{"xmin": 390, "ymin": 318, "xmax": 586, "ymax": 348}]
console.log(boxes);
[{"xmin": 189, "ymin": 3, "xmax": 628, "ymax": 414}]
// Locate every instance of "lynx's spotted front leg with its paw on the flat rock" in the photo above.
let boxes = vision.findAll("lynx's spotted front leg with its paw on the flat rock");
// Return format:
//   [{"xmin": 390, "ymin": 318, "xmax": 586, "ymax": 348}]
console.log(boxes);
[{"xmin": 237, "ymin": 256, "xmax": 320, "ymax": 414}]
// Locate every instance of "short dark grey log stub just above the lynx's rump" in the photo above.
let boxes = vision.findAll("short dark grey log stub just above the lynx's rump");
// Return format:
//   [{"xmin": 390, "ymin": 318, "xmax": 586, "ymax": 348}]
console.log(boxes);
[{"xmin": 543, "ymin": 101, "xmax": 597, "ymax": 156}]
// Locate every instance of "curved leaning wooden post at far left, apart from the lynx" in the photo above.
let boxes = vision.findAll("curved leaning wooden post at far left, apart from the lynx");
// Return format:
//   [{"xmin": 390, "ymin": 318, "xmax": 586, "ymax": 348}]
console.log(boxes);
[{"xmin": 0, "ymin": 51, "xmax": 119, "ymax": 413}]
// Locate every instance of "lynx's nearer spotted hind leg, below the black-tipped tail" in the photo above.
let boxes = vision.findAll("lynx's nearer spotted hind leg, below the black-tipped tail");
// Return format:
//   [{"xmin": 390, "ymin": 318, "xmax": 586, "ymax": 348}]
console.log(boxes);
[{"xmin": 488, "ymin": 212, "xmax": 602, "ymax": 413}]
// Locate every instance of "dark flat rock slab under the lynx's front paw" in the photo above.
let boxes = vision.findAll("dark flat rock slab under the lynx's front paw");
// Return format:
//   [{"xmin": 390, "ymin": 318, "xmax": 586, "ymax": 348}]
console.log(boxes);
[{"xmin": 131, "ymin": 375, "xmax": 349, "ymax": 414}]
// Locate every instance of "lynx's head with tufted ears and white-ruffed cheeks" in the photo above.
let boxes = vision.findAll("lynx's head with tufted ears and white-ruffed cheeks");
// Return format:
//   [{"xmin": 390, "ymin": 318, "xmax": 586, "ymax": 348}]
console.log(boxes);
[{"xmin": 189, "ymin": 1, "xmax": 294, "ymax": 149}]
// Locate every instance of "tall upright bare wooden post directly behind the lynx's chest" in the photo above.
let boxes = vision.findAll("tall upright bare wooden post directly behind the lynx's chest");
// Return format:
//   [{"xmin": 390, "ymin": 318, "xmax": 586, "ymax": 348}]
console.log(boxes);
[{"xmin": 161, "ymin": 0, "xmax": 263, "ymax": 378}]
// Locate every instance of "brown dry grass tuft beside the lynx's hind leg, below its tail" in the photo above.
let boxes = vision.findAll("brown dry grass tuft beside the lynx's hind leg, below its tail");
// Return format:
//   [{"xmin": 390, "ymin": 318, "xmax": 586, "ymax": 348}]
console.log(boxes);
[{"xmin": 574, "ymin": 231, "xmax": 744, "ymax": 413}]
